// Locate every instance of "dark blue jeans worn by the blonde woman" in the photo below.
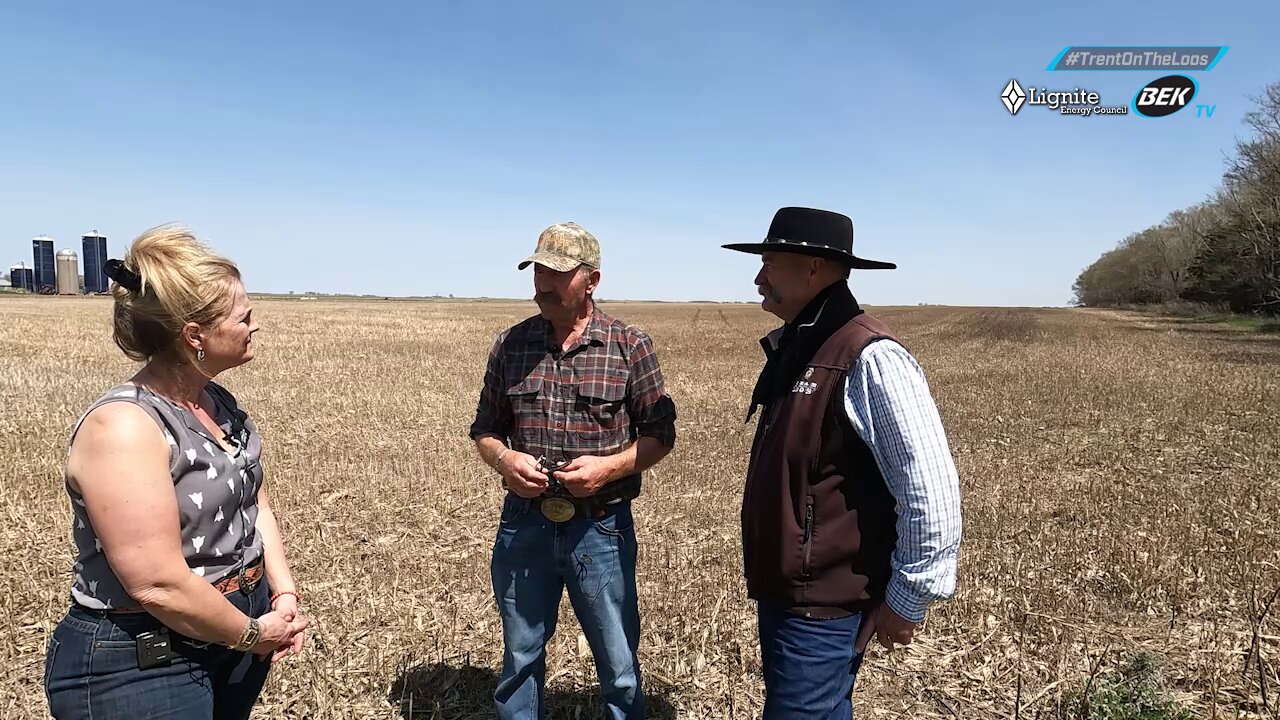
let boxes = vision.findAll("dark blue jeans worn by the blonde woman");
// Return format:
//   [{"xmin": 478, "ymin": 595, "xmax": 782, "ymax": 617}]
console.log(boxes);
[{"xmin": 45, "ymin": 579, "xmax": 271, "ymax": 720}]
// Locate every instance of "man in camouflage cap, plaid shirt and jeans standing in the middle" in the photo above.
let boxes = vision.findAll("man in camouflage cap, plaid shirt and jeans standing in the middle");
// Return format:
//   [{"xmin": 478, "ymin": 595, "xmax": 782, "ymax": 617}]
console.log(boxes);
[{"xmin": 471, "ymin": 223, "xmax": 676, "ymax": 720}]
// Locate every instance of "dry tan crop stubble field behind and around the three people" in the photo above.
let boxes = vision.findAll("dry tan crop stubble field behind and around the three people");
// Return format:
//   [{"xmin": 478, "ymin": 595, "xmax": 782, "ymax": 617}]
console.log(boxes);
[{"xmin": 0, "ymin": 299, "xmax": 1280, "ymax": 719}]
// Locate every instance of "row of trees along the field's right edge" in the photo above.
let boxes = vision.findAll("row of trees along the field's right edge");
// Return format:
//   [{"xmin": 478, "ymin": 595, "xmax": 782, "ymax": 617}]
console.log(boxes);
[{"xmin": 1071, "ymin": 82, "xmax": 1280, "ymax": 315}]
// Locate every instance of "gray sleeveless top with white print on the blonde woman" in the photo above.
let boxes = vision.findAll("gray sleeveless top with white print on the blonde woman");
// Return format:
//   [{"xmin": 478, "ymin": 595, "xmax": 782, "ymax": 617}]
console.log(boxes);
[{"xmin": 67, "ymin": 382, "xmax": 262, "ymax": 610}]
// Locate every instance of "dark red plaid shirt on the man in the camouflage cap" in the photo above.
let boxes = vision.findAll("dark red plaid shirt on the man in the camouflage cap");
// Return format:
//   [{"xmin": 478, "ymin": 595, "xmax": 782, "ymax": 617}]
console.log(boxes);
[{"xmin": 471, "ymin": 303, "xmax": 676, "ymax": 460}]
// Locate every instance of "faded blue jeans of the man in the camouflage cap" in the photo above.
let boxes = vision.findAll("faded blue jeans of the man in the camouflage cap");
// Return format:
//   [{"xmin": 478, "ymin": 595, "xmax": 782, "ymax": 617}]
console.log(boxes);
[{"xmin": 492, "ymin": 493, "xmax": 644, "ymax": 720}]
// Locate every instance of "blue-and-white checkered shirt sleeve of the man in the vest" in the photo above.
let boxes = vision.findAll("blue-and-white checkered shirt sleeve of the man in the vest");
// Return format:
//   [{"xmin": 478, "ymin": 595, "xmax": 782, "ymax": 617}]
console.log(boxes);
[{"xmin": 845, "ymin": 340, "xmax": 961, "ymax": 621}]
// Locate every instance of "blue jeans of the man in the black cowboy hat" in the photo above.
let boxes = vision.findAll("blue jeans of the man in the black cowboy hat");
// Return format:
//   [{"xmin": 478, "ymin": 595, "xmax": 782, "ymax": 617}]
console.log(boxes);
[{"xmin": 758, "ymin": 603, "xmax": 863, "ymax": 720}]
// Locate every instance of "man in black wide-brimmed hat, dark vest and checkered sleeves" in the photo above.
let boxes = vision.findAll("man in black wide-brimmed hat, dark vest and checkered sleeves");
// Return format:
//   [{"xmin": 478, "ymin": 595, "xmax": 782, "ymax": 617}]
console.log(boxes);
[{"xmin": 724, "ymin": 208, "xmax": 961, "ymax": 720}]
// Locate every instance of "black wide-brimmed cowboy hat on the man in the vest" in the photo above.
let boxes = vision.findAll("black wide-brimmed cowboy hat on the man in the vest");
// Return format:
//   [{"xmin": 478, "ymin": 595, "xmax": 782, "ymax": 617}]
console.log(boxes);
[{"xmin": 722, "ymin": 208, "xmax": 897, "ymax": 270}]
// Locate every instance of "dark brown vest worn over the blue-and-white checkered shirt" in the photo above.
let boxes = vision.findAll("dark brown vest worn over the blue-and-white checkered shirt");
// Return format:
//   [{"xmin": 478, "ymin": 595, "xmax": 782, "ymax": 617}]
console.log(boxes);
[{"xmin": 742, "ymin": 313, "xmax": 897, "ymax": 618}]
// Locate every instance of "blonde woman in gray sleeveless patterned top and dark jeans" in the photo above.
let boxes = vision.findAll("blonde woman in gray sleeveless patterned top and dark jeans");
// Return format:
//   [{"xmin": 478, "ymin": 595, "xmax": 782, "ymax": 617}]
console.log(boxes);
[{"xmin": 45, "ymin": 227, "xmax": 307, "ymax": 720}]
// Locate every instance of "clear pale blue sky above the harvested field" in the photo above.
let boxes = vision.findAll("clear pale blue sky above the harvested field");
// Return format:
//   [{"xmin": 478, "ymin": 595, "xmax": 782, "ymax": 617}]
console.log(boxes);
[{"xmin": 0, "ymin": 1, "xmax": 1280, "ymax": 306}]
